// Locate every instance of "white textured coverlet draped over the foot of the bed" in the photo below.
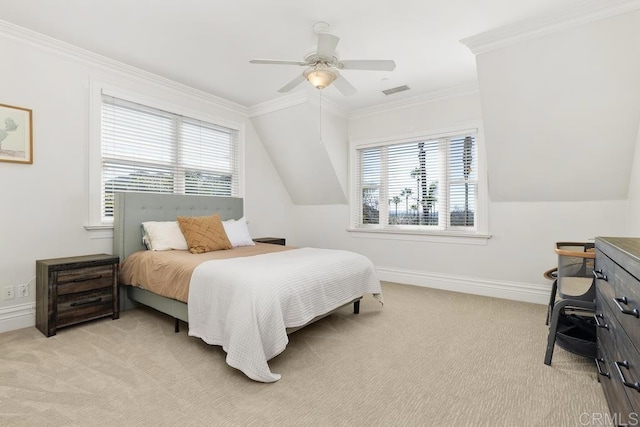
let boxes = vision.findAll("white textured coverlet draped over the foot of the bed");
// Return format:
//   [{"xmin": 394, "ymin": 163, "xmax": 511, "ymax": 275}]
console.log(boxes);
[{"xmin": 188, "ymin": 248, "xmax": 381, "ymax": 382}]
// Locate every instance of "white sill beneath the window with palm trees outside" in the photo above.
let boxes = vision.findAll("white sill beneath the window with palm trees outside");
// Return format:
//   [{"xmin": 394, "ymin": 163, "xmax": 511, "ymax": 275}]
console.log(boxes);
[{"xmin": 347, "ymin": 228, "xmax": 491, "ymax": 246}]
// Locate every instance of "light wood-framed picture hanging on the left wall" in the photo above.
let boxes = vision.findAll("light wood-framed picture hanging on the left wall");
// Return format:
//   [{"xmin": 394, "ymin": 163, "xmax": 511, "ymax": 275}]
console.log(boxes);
[{"xmin": 0, "ymin": 104, "xmax": 33, "ymax": 164}]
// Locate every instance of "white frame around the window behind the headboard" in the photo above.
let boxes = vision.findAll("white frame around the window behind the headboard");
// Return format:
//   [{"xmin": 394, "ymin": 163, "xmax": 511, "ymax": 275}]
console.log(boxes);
[{"xmin": 85, "ymin": 79, "xmax": 245, "ymax": 238}]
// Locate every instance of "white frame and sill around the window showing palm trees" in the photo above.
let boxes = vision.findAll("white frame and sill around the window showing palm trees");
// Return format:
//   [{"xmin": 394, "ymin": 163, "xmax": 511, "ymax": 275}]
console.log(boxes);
[{"xmin": 347, "ymin": 121, "xmax": 491, "ymax": 245}]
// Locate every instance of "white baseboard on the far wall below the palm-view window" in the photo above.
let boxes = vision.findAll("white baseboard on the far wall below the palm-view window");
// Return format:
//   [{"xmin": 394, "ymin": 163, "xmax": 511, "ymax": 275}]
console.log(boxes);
[{"xmin": 376, "ymin": 267, "xmax": 551, "ymax": 304}]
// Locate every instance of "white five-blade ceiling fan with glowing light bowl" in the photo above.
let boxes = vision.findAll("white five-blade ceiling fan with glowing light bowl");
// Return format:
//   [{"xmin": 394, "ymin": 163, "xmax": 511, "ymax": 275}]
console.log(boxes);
[{"xmin": 249, "ymin": 22, "xmax": 396, "ymax": 96}]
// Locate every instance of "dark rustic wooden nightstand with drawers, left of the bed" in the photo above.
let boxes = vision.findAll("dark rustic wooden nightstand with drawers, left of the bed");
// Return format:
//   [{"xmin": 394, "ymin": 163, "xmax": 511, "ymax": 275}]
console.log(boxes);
[{"xmin": 36, "ymin": 254, "xmax": 120, "ymax": 337}]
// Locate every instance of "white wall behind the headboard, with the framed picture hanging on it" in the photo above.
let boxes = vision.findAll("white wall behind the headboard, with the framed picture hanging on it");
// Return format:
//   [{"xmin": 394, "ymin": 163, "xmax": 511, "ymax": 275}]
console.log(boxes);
[{"xmin": 0, "ymin": 28, "xmax": 291, "ymax": 332}]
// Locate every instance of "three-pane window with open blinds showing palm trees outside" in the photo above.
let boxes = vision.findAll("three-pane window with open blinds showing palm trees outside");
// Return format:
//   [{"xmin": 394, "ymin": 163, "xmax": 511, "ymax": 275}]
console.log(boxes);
[{"xmin": 353, "ymin": 134, "xmax": 478, "ymax": 231}]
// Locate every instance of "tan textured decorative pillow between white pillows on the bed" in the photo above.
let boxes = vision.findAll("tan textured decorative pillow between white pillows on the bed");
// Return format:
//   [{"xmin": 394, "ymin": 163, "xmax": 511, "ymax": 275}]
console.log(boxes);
[{"xmin": 177, "ymin": 214, "xmax": 231, "ymax": 254}]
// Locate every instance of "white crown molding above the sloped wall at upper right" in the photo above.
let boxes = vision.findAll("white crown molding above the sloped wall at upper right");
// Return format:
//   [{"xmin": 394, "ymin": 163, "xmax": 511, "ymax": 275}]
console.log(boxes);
[{"xmin": 460, "ymin": 0, "xmax": 640, "ymax": 55}]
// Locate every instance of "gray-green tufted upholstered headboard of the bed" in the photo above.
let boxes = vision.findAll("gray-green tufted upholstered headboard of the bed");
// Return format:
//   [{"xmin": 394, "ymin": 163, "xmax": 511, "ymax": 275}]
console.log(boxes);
[{"xmin": 113, "ymin": 193, "xmax": 243, "ymax": 261}]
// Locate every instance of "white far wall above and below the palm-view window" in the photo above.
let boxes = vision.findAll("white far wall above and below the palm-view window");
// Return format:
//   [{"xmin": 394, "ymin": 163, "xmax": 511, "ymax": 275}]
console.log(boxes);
[{"xmin": 290, "ymin": 93, "xmax": 627, "ymax": 303}]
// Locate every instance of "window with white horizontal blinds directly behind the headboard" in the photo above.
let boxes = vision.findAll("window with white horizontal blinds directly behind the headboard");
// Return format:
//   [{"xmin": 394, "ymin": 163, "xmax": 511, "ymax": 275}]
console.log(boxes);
[{"xmin": 101, "ymin": 95, "xmax": 238, "ymax": 221}]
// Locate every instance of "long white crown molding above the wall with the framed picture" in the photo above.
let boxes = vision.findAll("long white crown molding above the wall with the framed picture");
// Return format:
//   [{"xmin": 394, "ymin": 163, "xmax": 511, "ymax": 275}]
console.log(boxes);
[{"xmin": 0, "ymin": 20, "xmax": 247, "ymax": 116}]
